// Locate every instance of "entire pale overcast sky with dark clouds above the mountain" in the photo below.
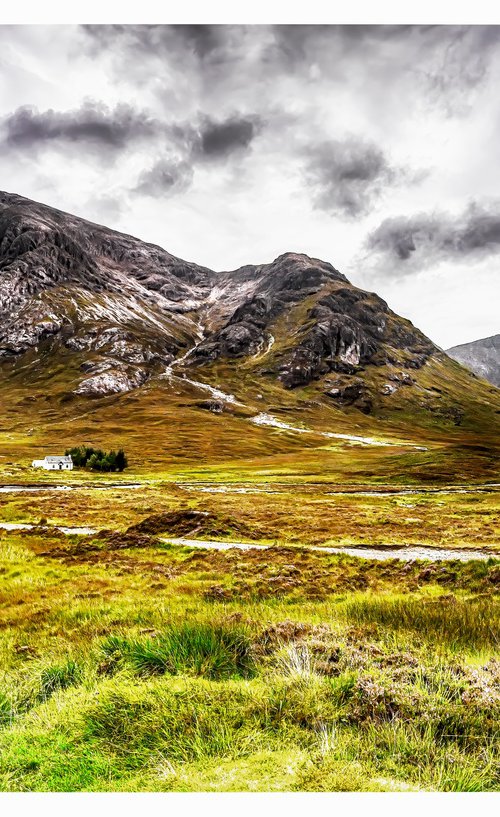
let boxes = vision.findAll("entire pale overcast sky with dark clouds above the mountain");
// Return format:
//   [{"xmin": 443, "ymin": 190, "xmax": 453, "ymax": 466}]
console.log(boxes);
[{"xmin": 0, "ymin": 25, "xmax": 500, "ymax": 348}]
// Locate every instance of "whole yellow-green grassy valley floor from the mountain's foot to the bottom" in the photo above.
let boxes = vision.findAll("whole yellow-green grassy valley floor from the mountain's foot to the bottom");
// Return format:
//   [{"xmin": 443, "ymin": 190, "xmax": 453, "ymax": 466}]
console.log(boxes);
[{"xmin": 0, "ymin": 472, "xmax": 500, "ymax": 791}]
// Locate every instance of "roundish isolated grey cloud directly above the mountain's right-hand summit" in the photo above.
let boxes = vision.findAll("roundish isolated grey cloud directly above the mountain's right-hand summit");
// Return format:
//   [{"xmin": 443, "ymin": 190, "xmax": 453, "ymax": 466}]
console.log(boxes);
[{"xmin": 304, "ymin": 138, "xmax": 397, "ymax": 218}]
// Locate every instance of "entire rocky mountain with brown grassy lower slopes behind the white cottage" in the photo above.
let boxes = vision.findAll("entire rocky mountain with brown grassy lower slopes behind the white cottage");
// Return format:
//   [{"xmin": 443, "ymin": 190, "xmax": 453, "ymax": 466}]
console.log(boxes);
[{"xmin": 0, "ymin": 193, "xmax": 500, "ymax": 475}]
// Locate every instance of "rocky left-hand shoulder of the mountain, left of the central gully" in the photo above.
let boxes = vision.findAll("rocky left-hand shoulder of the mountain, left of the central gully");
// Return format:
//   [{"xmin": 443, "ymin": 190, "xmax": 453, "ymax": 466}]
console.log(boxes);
[{"xmin": 0, "ymin": 193, "xmax": 213, "ymax": 394}]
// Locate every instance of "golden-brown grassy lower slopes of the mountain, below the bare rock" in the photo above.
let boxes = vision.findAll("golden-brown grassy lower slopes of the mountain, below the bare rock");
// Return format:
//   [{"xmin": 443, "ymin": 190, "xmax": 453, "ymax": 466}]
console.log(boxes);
[{"xmin": 0, "ymin": 332, "xmax": 500, "ymax": 482}]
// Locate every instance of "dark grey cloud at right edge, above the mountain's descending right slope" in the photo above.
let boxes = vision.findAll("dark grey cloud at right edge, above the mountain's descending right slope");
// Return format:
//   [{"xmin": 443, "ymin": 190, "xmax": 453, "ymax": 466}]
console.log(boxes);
[{"xmin": 365, "ymin": 201, "xmax": 500, "ymax": 277}]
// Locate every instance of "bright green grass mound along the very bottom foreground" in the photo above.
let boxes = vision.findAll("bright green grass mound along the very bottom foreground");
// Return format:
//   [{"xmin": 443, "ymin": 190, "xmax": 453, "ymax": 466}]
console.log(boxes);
[{"xmin": 0, "ymin": 674, "xmax": 499, "ymax": 791}]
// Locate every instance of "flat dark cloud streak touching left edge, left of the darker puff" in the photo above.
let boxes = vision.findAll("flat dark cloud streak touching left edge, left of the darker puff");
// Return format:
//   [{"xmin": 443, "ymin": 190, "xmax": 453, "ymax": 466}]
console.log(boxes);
[{"xmin": 2, "ymin": 102, "xmax": 161, "ymax": 151}]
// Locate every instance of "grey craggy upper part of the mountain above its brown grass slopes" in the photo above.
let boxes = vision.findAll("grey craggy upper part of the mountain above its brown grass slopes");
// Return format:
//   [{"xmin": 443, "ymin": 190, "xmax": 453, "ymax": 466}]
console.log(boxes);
[{"xmin": 0, "ymin": 188, "xmax": 435, "ymax": 395}]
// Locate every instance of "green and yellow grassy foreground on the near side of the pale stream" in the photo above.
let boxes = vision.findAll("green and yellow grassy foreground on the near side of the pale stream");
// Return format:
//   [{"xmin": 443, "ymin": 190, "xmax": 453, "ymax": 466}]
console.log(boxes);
[{"xmin": 0, "ymin": 534, "xmax": 500, "ymax": 791}]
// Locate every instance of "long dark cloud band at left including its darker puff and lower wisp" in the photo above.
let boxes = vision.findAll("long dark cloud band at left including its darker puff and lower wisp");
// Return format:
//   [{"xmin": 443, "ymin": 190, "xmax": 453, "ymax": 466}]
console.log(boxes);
[{"xmin": 0, "ymin": 93, "xmax": 262, "ymax": 201}]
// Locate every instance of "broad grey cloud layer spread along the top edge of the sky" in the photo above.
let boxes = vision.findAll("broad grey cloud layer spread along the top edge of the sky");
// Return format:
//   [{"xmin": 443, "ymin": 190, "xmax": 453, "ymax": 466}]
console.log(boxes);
[{"xmin": 81, "ymin": 25, "xmax": 500, "ymax": 121}]
